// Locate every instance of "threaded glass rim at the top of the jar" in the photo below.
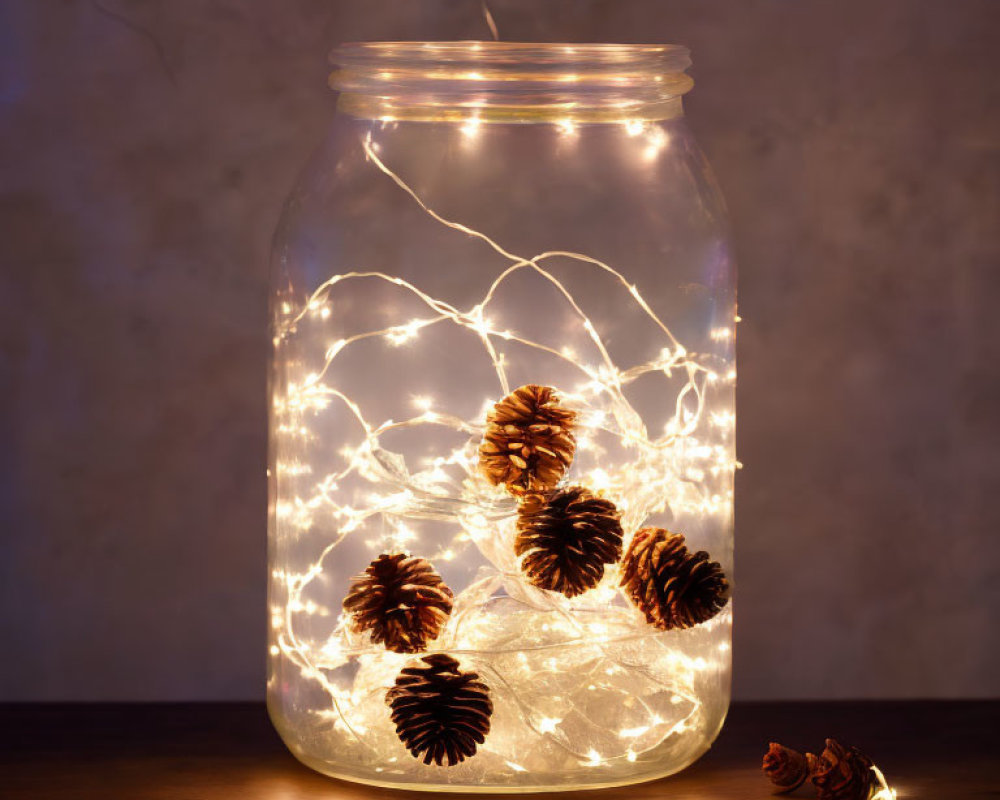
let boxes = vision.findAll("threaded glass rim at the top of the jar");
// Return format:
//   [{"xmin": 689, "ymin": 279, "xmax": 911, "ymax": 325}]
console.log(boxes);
[{"xmin": 329, "ymin": 41, "xmax": 693, "ymax": 119}]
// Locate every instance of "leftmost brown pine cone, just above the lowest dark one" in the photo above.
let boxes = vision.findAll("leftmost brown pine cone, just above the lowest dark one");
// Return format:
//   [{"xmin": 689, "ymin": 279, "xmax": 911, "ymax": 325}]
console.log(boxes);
[{"xmin": 344, "ymin": 553, "xmax": 453, "ymax": 653}]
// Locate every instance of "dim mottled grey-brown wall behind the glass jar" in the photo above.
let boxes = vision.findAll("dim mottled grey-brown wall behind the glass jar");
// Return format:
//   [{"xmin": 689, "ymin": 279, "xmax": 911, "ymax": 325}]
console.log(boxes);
[{"xmin": 0, "ymin": 0, "xmax": 1000, "ymax": 699}]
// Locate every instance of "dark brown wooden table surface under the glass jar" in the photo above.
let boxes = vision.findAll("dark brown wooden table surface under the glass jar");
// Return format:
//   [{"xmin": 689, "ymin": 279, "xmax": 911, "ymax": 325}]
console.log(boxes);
[{"xmin": 0, "ymin": 701, "xmax": 1000, "ymax": 800}]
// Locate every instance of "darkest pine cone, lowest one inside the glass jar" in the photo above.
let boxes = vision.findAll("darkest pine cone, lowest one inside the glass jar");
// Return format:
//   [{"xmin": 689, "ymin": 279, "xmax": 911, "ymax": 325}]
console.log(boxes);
[{"xmin": 385, "ymin": 653, "xmax": 493, "ymax": 767}]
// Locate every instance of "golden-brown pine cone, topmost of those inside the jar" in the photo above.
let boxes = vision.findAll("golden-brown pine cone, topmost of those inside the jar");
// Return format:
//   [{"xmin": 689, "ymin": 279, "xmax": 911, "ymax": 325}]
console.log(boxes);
[{"xmin": 479, "ymin": 384, "xmax": 576, "ymax": 495}]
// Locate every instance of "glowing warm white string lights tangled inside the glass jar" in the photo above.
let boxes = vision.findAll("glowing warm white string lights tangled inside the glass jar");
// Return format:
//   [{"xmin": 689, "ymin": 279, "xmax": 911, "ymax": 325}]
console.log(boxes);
[{"xmin": 271, "ymin": 125, "xmax": 740, "ymax": 780}]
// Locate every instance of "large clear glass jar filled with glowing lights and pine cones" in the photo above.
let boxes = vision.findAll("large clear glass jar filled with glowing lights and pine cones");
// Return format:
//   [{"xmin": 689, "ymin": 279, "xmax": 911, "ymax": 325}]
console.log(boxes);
[{"xmin": 268, "ymin": 42, "xmax": 737, "ymax": 792}]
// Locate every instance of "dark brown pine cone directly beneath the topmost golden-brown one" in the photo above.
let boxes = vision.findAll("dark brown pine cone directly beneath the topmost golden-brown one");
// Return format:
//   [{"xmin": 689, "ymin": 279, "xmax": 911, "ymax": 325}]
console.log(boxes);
[{"xmin": 514, "ymin": 486, "xmax": 622, "ymax": 597}]
